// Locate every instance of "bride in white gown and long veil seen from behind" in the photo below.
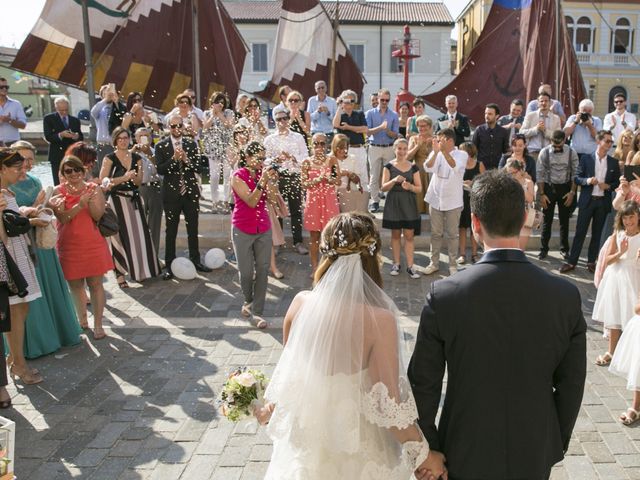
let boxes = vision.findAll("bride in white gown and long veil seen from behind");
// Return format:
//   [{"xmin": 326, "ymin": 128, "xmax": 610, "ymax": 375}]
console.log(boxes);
[{"xmin": 256, "ymin": 213, "xmax": 446, "ymax": 480}]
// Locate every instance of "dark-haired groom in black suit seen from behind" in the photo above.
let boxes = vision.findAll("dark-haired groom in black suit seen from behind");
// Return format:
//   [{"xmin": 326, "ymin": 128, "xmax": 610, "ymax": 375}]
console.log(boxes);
[{"xmin": 408, "ymin": 170, "xmax": 586, "ymax": 480}]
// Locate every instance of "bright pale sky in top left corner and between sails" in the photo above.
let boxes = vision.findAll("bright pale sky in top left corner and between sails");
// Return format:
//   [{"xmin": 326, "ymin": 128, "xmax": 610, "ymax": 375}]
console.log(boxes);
[{"xmin": 0, "ymin": 0, "xmax": 469, "ymax": 48}]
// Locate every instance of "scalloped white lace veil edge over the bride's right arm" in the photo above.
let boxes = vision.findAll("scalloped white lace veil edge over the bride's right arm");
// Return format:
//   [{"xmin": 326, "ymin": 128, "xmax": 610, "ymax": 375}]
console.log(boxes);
[{"xmin": 362, "ymin": 382, "xmax": 418, "ymax": 430}]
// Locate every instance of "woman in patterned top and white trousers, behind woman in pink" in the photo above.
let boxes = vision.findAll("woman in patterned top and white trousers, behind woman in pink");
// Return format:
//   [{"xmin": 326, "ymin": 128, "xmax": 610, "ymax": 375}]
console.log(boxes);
[{"xmin": 202, "ymin": 92, "xmax": 235, "ymax": 213}]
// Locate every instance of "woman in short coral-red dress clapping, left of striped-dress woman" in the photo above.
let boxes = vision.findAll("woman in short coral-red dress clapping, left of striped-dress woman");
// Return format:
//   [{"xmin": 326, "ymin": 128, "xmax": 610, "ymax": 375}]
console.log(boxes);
[{"xmin": 50, "ymin": 156, "xmax": 113, "ymax": 340}]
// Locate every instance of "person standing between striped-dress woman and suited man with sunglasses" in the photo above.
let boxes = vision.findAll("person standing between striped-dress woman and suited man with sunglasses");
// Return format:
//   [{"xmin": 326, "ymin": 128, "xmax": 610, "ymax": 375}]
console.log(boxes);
[{"xmin": 131, "ymin": 128, "xmax": 162, "ymax": 255}]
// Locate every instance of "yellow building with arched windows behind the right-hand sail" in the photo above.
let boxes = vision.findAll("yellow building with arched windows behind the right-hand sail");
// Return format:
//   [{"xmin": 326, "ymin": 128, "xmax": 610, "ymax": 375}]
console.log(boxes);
[{"xmin": 456, "ymin": 0, "xmax": 640, "ymax": 118}]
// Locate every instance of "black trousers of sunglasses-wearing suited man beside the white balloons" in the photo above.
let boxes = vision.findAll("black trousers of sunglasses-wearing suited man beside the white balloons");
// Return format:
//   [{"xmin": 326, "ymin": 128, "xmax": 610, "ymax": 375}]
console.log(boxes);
[{"xmin": 162, "ymin": 194, "xmax": 200, "ymax": 269}]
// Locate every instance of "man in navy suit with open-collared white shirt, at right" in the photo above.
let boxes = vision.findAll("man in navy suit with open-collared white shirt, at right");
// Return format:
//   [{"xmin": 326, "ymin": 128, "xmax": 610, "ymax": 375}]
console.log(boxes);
[{"xmin": 560, "ymin": 130, "xmax": 620, "ymax": 273}]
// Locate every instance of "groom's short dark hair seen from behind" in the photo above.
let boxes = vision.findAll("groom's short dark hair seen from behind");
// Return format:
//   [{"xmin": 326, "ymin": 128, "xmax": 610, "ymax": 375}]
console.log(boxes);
[{"xmin": 471, "ymin": 170, "xmax": 524, "ymax": 238}]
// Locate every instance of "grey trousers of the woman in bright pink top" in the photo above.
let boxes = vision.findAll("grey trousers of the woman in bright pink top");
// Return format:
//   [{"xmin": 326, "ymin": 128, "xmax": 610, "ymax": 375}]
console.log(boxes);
[{"xmin": 232, "ymin": 227, "xmax": 271, "ymax": 315}]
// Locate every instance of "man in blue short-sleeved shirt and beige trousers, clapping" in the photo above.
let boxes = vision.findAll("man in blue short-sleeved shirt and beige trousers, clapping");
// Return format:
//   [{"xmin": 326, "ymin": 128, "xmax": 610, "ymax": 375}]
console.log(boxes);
[{"xmin": 365, "ymin": 88, "xmax": 400, "ymax": 213}]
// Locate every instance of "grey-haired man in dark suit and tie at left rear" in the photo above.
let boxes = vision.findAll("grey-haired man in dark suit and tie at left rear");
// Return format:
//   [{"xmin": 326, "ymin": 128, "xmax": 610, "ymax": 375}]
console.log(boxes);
[{"xmin": 42, "ymin": 97, "xmax": 83, "ymax": 185}]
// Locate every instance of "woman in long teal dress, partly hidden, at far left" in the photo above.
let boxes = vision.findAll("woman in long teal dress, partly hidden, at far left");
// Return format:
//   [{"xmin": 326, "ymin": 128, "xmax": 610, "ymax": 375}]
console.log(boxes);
[{"xmin": 10, "ymin": 141, "xmax": 82, "ymax": 358}]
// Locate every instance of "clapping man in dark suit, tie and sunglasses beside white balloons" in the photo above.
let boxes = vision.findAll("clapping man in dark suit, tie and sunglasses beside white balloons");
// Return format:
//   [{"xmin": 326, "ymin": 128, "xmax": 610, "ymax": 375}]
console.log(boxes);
[{"xmin": 155, "ymin": 115, "xmax": 211, "ymax": 280}]
